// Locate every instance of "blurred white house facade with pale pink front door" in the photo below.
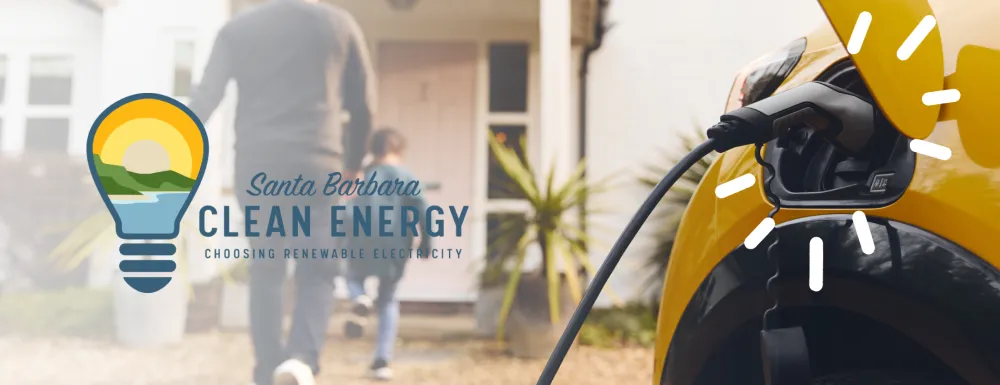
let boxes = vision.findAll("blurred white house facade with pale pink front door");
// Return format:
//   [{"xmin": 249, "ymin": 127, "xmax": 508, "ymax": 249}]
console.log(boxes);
[{"xmin": 0, "ymin": 0, "xmax": 822, "ymax": 302}]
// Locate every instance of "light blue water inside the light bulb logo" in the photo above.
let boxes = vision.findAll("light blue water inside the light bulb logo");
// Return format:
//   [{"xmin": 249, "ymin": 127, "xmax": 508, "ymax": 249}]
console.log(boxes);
[{"xmin": 111, "ymin": 192, "xmax": 190, "ymax": 234}]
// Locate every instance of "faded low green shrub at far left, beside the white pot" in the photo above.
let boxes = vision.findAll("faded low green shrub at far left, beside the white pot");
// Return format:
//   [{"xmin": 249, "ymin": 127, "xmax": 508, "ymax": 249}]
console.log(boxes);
[{"xmin": 0, "ymin": 288, "xmax": 114, "ymax": 338}]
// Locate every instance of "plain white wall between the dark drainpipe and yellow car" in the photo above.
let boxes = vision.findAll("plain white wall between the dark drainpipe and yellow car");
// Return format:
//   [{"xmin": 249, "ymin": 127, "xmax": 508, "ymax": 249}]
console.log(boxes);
[{"xmin": 587, "ymin": 0, "xmax": 826, "ymax": 304}]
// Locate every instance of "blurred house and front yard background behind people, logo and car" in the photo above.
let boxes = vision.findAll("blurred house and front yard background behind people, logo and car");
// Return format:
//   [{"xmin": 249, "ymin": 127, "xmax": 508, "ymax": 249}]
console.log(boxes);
[{"xmin": 0, "ymin": 0, "xmax": 826, "ymax": 385}]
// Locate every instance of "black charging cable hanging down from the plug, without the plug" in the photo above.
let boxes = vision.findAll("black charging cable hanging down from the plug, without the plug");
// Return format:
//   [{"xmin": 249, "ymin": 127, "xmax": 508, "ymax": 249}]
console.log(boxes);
[{"xmin": 538, "ymin": 138, "xmax": 731, "ymax": 385}]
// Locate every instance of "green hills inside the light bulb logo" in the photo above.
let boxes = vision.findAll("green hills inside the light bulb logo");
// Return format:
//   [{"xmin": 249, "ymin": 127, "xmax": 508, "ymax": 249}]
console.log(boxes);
[{"xmin": 94, "ymin": 155, "xmax": 195, "ymax": 195}]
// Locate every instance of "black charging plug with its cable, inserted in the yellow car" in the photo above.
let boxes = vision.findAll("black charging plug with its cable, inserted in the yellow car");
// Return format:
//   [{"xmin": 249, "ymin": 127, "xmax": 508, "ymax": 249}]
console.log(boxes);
[{"xmin": 537, "ymin": 82, "xmax": 885, "ymax": 385}]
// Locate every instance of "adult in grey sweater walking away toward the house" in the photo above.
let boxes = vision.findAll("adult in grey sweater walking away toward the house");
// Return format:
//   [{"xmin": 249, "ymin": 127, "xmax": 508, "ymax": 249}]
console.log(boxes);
[{"xmin": 190, "ymin": 0, "xmax": 375, "ymax": 385}]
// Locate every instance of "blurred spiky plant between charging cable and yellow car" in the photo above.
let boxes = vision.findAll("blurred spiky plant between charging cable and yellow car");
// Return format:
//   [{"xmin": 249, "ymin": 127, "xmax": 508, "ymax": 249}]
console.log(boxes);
[{"xmin": 639, "ymin": 130, "xmax": 715, "ymax": 303}]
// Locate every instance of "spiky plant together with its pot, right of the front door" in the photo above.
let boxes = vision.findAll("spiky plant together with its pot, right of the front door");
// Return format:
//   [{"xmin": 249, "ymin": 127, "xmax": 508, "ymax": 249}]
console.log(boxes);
[{"xmin": 484, "ymin": 131, "xmax": 605, "ymax": 358}]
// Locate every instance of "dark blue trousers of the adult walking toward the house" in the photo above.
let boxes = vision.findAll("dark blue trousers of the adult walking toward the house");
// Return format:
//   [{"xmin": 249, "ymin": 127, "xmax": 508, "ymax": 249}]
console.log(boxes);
[{"xmin": 234, "ymin": 160, "xmax": 341, "ymax": 385}]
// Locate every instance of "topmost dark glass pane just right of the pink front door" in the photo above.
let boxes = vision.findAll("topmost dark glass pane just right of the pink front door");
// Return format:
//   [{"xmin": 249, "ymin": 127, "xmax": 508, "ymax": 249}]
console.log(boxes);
[{"xmin": 490, "ymin": 43, "xmax": 528, "ymax": 112}]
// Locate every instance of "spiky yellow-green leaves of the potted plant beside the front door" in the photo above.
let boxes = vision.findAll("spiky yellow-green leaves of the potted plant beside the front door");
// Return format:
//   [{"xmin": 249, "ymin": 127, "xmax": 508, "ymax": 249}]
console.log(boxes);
[{"xmin": 484, "ymin": 131, "xmax": 607, "ymax": 340}]
